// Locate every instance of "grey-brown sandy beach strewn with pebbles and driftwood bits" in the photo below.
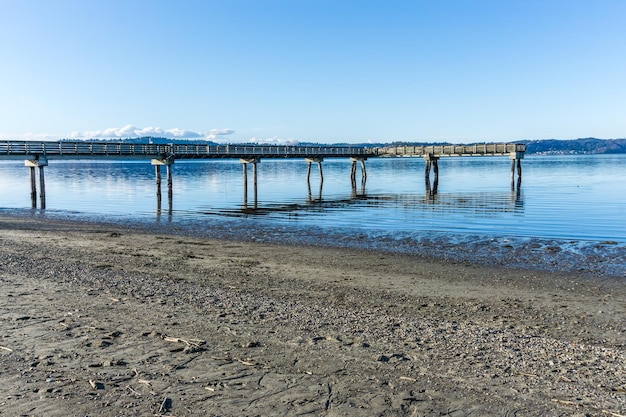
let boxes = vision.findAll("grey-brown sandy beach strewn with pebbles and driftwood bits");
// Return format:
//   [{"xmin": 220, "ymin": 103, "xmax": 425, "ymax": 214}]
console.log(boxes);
[{"xmin": 0, "ymin": 217, "xmax": 626, "ymax": 417}]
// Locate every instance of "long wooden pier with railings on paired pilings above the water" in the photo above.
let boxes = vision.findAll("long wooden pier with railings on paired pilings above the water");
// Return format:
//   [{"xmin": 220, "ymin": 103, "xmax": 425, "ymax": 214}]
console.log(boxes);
[{"xmin": 0, "ymin": 141, "xmax": 526, "ymax": 212}]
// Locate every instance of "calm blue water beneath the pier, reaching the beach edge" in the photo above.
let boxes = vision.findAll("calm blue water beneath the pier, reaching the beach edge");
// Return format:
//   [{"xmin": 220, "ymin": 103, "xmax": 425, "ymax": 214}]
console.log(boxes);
[{"xmin": 0, "ymin": 155, "xmax": 626, "ymax": 272}]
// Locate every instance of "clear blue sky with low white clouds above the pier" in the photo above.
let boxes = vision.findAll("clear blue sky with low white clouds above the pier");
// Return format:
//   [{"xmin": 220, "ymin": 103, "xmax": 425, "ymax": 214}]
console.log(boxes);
[{"xmin": 0, "ymin": 0, "xmax": 626, "ymax": 143}]
